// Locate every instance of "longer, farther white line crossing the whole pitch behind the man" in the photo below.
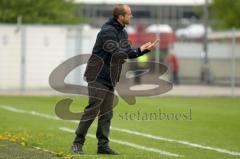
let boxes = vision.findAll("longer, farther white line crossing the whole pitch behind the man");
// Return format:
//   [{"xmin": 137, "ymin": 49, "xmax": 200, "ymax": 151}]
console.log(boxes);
[{"xmin": 0, "ymin": 105, "xmax": 240, "ymax": 156}]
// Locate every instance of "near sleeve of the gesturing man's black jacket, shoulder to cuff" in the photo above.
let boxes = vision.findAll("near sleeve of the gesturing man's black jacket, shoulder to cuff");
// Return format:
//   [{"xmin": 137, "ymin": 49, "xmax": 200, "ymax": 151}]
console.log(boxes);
[{"xmin": 100, "ymin": 30, "xmax": 150, "ymax": 59}]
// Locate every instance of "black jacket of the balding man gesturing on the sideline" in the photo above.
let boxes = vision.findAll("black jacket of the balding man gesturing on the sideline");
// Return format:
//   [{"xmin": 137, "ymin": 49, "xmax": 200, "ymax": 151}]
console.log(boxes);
[{"xmin": 85, "ymin": 18, "xmax": 149, "ymax": 86}]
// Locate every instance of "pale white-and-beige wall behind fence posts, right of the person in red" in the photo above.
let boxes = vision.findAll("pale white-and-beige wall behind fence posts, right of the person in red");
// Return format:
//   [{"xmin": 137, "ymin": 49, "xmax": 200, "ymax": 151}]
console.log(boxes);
[{"xmin": 173, "ymin": 41, "xmax": 240, "ymax": 85}]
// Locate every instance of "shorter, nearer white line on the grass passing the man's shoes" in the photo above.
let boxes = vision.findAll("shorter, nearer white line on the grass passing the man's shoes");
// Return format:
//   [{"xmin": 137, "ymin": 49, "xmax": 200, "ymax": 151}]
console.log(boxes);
[{"xmin": 59, "ymin": 127, "xmax": 180, "ymax": 157}]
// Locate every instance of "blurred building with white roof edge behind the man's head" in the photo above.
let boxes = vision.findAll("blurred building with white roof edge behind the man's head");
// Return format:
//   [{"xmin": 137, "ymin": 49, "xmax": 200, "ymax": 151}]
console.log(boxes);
[{"xmin": 75, "ymin": 0, "xmax": 210, "ymax": 29}]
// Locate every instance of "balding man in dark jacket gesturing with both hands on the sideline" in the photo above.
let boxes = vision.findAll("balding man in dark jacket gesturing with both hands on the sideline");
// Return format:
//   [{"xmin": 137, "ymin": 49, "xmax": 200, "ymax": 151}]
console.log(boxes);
[{"xmin": 72, "ymin": 4, "xmax": 157, "ymax": 155}]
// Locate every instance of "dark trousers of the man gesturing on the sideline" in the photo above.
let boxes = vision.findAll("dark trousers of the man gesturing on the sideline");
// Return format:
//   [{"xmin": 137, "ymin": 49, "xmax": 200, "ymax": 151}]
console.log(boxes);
[{"xmin": 74, "ymin": 82, "xmax": 114, "ymax": 148}]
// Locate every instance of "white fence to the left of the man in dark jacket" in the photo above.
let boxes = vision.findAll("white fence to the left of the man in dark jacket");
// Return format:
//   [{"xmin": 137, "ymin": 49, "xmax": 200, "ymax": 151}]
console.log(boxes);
[{"xmin": 0, "ymin": 25, "xmax": 98, "ymax": 90}]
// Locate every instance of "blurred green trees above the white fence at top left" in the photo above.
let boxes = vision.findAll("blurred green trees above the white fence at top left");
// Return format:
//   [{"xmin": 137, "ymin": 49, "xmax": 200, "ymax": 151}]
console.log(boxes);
[{"xmin": 0, "ymin": 0, "xmax": 85, "ymax": 24}]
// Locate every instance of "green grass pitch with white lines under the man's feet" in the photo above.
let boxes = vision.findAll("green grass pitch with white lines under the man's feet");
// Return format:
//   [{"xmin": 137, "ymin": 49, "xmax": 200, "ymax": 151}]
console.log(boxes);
[{"xmin": 0, "ymin": 96, "xmax": 240, "ymax": 159}]
